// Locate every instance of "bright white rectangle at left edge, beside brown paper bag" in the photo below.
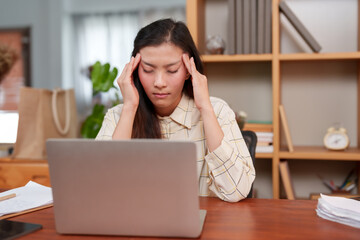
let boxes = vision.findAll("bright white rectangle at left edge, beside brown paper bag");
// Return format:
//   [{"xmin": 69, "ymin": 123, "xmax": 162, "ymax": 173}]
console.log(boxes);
[{"xmin": 0, "ymin": 111, "xmax": 19, "ymax": 144}]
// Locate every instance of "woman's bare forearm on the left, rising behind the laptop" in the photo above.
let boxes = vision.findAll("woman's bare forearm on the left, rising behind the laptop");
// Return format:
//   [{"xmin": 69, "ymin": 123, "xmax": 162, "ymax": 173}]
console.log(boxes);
[{"xmin": 112, "ymin": 106, "xmax": 137, "ymax": 140}]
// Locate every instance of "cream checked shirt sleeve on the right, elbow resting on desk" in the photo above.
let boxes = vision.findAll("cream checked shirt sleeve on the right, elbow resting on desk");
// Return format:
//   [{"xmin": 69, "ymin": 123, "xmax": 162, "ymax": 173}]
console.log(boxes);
[{"xmin": 205, "ymin": 102, "xmax": 255, "ymax": 202}]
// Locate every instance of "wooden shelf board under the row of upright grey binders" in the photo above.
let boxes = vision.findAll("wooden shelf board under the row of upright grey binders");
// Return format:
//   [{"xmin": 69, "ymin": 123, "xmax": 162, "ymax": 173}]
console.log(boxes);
[{"xmin": 201, "ymin": 54, "xmax": 272, "ymax": 63}]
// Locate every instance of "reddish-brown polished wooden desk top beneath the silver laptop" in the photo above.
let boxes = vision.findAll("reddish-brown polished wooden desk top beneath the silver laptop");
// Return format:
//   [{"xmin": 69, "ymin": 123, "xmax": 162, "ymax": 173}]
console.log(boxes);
[{"xmin": 7, "ymin": 197, "xmax": 360, "ymax": 240}]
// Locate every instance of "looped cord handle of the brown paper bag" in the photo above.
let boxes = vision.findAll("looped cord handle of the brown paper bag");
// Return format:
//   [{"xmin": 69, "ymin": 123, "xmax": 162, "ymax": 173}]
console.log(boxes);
[{"xmin": 51, "ymin": 88, "xmax": 71, "ymax": 136}]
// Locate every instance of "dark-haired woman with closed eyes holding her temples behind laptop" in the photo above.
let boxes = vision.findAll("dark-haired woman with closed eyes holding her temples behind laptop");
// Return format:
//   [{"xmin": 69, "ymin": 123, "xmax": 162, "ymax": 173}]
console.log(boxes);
[{"xmin": 96, "ymin": 19, "xmax": 255, "ymax": 202}]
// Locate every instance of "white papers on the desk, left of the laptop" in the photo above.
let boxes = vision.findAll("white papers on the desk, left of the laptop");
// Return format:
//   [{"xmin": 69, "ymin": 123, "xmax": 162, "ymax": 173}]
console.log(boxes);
[{"xmin": 0, "ymin": 181, "xmax": 53, "ymax": 217}]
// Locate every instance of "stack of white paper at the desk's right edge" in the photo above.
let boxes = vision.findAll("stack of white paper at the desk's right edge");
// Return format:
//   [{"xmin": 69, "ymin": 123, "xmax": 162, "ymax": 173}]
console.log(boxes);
[{"xmin": 316, "ymin": 194, "xmax": 360, "ymax": 228}]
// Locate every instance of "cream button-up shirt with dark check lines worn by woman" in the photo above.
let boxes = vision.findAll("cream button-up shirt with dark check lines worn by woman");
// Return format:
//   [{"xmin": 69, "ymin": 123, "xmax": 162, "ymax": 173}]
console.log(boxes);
[{"xmin": 96, "ymin": 95, "xmax": 255, "ymax": 202}]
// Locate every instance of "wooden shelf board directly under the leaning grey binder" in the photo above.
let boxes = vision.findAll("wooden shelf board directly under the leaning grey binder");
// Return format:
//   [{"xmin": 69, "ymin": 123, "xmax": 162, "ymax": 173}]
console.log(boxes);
[{"xmin": 279, "ymin": 52, "xmax": 360, "ymax": 61}]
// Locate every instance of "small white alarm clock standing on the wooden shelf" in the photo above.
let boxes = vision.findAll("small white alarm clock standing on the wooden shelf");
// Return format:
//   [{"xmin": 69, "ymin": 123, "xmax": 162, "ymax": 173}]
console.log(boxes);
[{"xmin": 324, "ymin": 127, "xmax": 350, "ymax": 150}]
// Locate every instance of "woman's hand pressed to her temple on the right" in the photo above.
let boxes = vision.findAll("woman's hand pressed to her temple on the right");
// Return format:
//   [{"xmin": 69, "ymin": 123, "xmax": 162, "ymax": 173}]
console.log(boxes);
[{"xmin": 182, "ymin": 53, "xmax": 212, "ymax": 112}]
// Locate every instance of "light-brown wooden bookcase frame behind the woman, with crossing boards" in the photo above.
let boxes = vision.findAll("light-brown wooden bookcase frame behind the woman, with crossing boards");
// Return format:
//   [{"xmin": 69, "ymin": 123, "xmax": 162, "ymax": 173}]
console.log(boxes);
[{"xmin": 186, "ymin": 0, "xmax": 360, "ymax": 199}]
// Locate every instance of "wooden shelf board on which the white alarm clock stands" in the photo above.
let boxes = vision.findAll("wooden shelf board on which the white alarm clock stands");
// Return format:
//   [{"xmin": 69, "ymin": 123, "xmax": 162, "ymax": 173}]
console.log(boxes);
[{"xmin": 279, "ymin": 146, "xmax": 360, "ymax": 161}]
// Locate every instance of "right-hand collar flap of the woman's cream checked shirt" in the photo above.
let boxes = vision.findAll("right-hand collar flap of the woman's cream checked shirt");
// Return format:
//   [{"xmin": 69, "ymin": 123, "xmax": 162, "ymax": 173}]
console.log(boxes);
[{"xmin": 170, "ymin": 94, "xmax": 194, "ymax": 129}]
